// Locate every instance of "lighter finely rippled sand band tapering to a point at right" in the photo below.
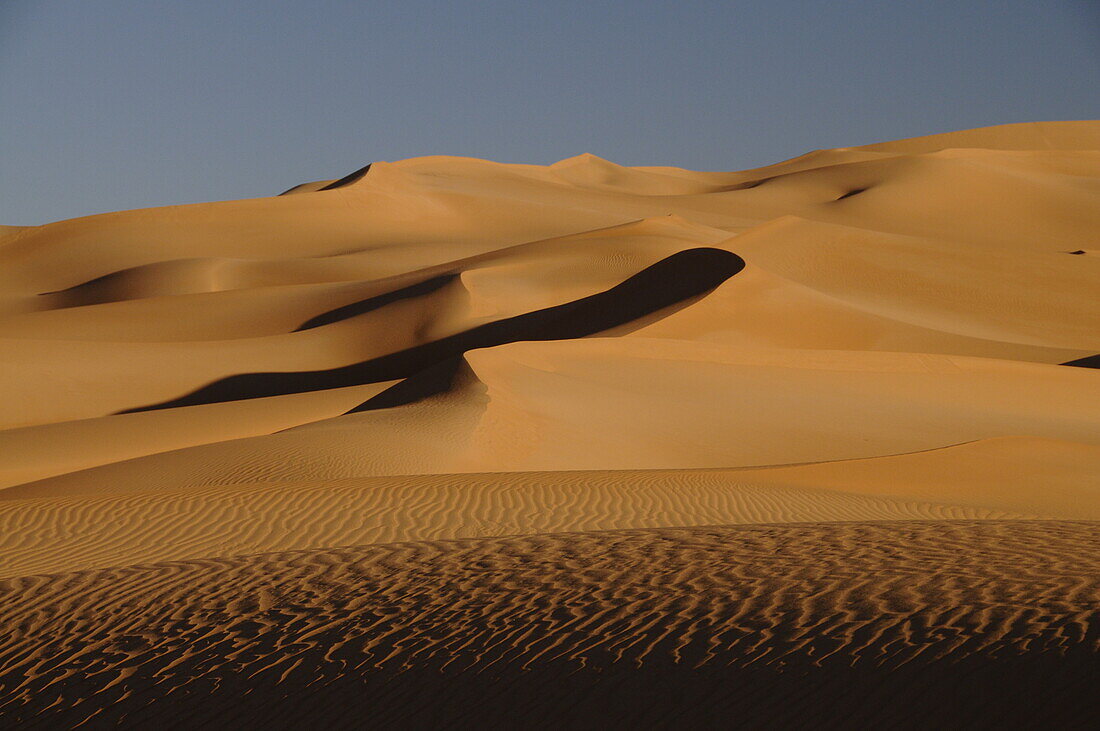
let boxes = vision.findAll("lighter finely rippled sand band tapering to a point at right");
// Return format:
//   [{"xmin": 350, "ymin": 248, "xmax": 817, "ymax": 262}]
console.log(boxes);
[{"xmin": 0, "ymin": 469, "xmax": 1036, "ymax": 577}]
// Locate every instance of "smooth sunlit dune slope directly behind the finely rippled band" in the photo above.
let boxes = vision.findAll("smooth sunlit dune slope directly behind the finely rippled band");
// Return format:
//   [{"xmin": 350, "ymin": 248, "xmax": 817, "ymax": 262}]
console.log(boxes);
[{"xmin": 8, "ymin": 337, "xmax": 1100, "ymax": 499}]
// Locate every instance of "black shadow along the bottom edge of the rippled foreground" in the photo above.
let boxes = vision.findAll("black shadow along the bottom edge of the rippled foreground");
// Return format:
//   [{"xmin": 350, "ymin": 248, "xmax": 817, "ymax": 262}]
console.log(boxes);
[{"xmin": 4, "ymin": 651, "xmax": 1100, "ymax": 731}]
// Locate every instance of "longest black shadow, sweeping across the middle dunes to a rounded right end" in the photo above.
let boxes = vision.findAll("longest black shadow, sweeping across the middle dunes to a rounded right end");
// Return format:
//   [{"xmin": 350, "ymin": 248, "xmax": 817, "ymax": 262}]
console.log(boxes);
[{"xmin": 119, "ymin": 247, "xmax": 745, "ymax": 413}]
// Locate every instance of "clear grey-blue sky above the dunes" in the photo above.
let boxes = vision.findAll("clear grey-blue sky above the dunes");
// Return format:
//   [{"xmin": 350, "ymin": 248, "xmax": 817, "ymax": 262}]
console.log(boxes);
[{"xmin": 0, "ymin": 0, "xmax": 1100, "ymax": 224}]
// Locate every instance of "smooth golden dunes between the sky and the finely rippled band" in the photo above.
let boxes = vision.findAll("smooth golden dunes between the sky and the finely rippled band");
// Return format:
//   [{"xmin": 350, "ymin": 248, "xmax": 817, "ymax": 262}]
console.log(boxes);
[{"xmin": 0, "ymin": 122, "xmax": 1100, "ymax": 514}]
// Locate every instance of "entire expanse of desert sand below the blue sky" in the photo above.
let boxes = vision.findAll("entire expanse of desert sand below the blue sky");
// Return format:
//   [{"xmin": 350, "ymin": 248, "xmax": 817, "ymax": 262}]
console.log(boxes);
[{"xmin": 0, "ymin": 122, "xmax": 1100, "ymax": 729}]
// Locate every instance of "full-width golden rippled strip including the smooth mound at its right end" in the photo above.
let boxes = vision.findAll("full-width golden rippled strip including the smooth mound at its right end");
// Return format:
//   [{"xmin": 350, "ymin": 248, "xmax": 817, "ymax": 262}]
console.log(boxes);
[{"xmin": 0, "ymin": 438, "xmax": 1100, "ymax": 577}]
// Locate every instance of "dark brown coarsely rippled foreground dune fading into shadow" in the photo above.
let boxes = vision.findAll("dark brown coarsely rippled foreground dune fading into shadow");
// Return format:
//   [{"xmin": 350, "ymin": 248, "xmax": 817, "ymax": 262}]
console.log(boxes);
[{"xmin": 0, "ymin": 521, "xmax": 1100, "ymax": 728}]
